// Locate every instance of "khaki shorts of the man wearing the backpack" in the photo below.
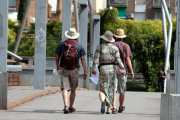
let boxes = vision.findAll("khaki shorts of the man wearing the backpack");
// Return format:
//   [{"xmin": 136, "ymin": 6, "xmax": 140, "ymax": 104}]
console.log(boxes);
[{"xmin": 60, "ymin": 68, "xmax": 79, "ymax": 91}]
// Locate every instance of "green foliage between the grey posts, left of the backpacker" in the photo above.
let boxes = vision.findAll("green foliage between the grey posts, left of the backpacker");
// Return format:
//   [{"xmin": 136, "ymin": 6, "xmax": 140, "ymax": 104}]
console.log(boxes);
[{"xmin": 8, "ymin": 19, "xmax": 62, "ymax": 57}]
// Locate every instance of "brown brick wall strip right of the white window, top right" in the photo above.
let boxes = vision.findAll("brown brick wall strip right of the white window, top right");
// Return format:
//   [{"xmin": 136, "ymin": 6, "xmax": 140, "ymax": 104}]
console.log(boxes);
[{"xmin": 146, "ymin": 0, "xmax": 154, "ymax": 19}]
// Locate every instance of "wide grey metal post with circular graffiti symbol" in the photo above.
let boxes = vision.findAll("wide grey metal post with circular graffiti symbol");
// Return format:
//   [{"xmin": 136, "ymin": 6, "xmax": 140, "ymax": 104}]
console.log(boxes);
[{"xmin": 34, "ymin": 0, "xmax": 47, "ymax": 89}]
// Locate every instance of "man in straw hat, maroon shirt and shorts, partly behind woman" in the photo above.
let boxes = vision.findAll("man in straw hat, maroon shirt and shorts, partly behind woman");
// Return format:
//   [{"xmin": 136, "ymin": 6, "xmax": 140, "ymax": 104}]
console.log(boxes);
[{"xmin": 112, "ymin": 29, "xmax": 134, "ymax": 113}]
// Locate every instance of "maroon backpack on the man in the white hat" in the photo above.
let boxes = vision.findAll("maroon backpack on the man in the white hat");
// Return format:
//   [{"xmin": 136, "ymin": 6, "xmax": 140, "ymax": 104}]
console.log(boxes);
[{"xmin": 60, "ymin": 39, "xmax": 79, "ymax": 70}]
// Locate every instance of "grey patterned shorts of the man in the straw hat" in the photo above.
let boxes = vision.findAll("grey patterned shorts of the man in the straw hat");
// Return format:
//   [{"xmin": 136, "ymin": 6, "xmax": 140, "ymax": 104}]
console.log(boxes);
[{"xmin": 117, "ymin": 74, "xmax": 127, "ymax": 94}]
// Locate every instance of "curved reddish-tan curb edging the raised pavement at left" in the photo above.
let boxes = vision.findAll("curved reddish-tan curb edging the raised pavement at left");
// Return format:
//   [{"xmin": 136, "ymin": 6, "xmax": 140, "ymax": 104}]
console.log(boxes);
[{"xmin": 7, "ymin": 88, "xmax": 88, "ymax": 109}]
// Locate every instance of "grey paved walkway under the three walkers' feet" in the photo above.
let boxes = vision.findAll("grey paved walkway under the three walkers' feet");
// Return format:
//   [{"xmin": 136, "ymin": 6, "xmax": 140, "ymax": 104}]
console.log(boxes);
[{"xmin": 0, "ymin": 91, "xmax": 161, "ymax": 120}]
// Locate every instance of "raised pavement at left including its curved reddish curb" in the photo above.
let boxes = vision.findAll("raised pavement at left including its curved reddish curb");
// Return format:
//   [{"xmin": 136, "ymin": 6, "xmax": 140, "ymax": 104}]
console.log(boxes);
[{"xmin": 8, "ymin": 86, "xmax": 87, "ymax": 109}]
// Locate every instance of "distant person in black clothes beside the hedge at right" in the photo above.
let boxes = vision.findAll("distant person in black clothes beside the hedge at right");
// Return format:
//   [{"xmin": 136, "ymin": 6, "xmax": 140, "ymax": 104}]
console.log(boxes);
[{"xmin": 156, "ymin": 69, "xmax": 167, "ymax": 92}]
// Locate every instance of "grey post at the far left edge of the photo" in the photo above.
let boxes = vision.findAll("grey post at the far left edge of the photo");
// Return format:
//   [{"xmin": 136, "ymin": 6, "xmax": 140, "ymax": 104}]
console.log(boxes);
[{"xmin": 0, "ymin": 0, "xmax": 8, "ymax": 110}]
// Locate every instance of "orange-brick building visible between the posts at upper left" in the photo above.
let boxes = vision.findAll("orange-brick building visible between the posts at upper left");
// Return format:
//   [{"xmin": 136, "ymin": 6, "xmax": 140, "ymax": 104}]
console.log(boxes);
[{"xmin": 8, "ymin": 0, "xmax": 75, "ymax": 26}]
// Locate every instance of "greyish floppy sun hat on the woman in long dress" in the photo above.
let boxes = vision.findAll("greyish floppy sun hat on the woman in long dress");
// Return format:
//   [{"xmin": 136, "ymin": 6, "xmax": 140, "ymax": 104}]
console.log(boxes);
[{"xmin": 100, "ymin": 31, "xmax": 115, "ymax": 42}]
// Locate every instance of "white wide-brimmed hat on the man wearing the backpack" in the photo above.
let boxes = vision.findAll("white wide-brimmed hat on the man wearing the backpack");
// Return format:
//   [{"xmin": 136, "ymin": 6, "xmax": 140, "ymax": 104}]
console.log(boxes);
[{"xmin": 65, "ymin": 28, "xmax": 79, "ymax": 39}]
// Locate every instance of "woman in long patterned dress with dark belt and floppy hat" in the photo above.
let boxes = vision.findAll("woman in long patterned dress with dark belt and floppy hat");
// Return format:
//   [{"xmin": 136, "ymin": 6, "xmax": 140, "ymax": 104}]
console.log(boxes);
[{"xmin": 92, "ymin": 31, "xmax": 126, "ymax": 114}]
